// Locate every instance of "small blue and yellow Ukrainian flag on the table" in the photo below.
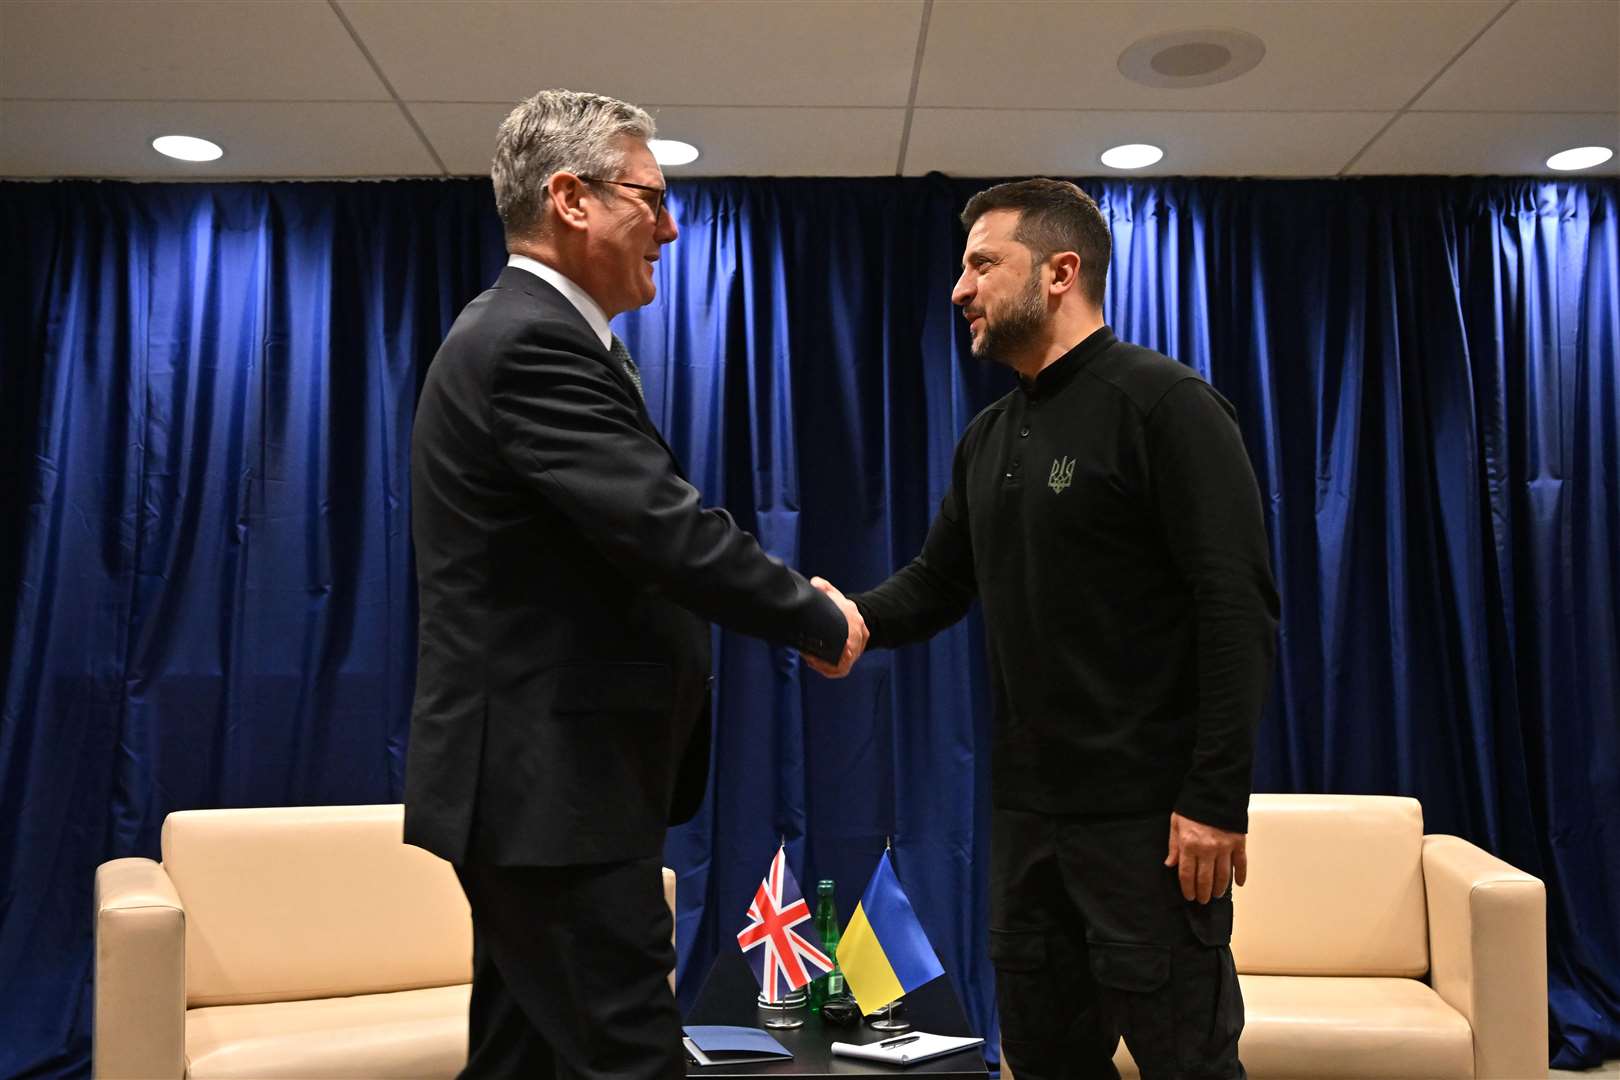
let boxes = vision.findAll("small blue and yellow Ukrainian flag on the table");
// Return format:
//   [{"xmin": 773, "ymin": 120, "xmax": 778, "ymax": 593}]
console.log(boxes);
[{"xmin": 838, "ymin": 850, "xmax": 944, "ymax": 1014}]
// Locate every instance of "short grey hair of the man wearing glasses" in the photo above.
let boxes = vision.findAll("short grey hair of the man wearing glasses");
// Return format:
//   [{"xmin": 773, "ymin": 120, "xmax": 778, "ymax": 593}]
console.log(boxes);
[{"xmin": 489, "ymin": 89, "xmax": 654, "ymax": 238}]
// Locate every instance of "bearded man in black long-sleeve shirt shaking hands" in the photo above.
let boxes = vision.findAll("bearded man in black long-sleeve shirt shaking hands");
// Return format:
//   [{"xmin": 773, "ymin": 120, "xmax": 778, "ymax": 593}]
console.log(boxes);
[{"xmin": 812, "ymin": 180, "xmax": 1278, "ymax": 1080}]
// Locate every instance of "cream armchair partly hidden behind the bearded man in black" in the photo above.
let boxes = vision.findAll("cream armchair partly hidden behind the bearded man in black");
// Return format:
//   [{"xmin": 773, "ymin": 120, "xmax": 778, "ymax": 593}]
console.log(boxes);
[{"xmin": 1003, "ymin": 795, "xmax": 1547, "ymax": 1080}]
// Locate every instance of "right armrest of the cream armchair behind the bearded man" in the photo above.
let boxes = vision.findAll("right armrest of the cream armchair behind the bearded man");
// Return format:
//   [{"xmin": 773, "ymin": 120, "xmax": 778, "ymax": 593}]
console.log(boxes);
[{"xmin": 1422, "ymin": 836, "xmax": 1549, "ymax": 1080}]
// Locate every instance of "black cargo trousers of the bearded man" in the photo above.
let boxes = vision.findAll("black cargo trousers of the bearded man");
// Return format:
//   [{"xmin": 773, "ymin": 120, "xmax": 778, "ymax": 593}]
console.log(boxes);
[{"xmin": 990, "ymin": 810, "xmax": 1246, "ymax": 1080}]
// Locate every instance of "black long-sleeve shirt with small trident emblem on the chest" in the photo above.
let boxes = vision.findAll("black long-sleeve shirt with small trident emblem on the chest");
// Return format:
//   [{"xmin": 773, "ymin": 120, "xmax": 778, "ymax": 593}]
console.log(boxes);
[{"xmin": 851, "ymin": 327, "xmax": 1278, "ymax": 832}]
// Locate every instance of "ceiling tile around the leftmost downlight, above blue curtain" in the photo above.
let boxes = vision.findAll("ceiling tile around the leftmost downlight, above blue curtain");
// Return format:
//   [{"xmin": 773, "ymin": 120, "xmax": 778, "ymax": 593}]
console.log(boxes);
[{"xmin": 0, "ymin": 100, "xmax": 439, "ymax": 180}]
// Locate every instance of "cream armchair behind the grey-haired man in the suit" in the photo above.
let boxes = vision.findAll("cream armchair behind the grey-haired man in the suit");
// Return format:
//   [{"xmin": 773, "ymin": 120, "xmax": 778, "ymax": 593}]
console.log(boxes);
[{"xmin": 92, "ymin": 805, "xmax": 674, "ymax": 1080}]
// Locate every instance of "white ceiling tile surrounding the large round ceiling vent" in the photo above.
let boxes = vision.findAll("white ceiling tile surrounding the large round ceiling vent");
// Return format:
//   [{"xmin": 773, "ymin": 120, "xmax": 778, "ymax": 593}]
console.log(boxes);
[{"xmin": 917, "ymin": 0, "xmax": 1507, "ymax": 112}]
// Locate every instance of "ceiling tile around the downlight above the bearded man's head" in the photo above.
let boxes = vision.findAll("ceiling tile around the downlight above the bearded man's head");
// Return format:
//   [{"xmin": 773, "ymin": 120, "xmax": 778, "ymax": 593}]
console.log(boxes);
[{"xmin": 906, "ymin": 108, "xmax": 1388, "ymax": 176}]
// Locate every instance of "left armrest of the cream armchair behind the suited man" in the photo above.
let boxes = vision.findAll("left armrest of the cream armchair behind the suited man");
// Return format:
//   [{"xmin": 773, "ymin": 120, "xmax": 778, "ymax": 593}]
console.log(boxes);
[{"xmin": 91, "ymin": 858, "xmax": 186, "ymax": 1080}]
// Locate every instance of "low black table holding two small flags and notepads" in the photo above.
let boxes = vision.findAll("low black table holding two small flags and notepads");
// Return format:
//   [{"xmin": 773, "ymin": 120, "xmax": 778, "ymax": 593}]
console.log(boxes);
[{"xmin": 687, "ymin": 946, "xmax": 990, "ymax": 1080}]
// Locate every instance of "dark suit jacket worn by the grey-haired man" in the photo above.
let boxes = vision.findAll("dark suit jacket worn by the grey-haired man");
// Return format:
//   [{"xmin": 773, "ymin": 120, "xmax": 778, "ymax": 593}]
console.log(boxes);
[{"xmin": 405, "ymin": 267, "xmax": 846, "ymax": 866}]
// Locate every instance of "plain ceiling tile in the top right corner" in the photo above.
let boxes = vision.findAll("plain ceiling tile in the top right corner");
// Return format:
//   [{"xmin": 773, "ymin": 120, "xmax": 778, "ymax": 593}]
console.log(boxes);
[{"xmin": 1413, "ymin": 0, "xmax": 1620, "ymax": 113}]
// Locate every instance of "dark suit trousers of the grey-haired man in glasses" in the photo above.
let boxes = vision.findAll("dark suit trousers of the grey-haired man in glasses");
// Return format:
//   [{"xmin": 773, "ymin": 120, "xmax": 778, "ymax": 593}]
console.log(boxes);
[{"xmin": 455, "ymin": 858, "xmax": 685, "ymax": 1080}]
